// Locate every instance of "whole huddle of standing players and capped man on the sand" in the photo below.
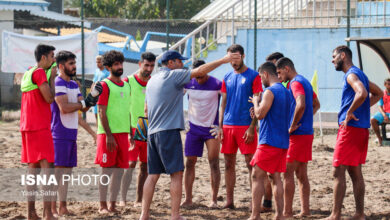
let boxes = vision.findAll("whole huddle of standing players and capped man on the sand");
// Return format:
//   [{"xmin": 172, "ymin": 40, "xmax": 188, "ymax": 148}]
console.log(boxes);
[{"xmin": 20, "ymin": 41, "xmax": 383, "ymax": 219}]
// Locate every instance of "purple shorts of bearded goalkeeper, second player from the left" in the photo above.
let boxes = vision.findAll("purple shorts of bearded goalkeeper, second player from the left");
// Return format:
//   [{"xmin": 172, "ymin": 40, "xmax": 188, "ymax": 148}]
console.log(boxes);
[{"xmin": 53, "ymin": 139, "xmax": 77, "ymax": 167}]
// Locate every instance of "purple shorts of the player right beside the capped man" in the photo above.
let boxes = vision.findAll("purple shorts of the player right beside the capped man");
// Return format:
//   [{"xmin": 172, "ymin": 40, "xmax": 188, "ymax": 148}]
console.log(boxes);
[{"xmin": 184, "ymin": 122, "xmax": 215, "ymax": 157}]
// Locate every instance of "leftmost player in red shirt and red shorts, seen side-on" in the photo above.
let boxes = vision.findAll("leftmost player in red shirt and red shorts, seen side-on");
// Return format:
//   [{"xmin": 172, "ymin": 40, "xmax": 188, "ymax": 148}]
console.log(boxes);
[{"xmin": 20, "ymin": 44, "xmax": 57, "ymax": 219}]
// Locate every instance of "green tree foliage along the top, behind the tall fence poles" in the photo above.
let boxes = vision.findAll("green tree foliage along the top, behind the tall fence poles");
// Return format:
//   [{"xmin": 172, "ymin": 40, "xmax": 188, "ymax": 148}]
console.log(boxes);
[{"xmin": 65, "ymin": 0, "xmax": 210, "ymax": 19}]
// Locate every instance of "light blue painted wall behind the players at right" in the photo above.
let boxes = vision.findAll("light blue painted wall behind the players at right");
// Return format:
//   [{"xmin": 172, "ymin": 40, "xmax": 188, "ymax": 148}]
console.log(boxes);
[{"xmin": 201, "ymin": 27, "xmax": 390, "ymax": 112}]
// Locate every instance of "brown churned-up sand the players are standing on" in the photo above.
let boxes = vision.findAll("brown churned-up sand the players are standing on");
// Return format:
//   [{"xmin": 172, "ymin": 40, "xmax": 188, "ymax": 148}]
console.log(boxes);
[{"xmin": 0, "ymin": 120, "xmax": 390, "ymax": 220}]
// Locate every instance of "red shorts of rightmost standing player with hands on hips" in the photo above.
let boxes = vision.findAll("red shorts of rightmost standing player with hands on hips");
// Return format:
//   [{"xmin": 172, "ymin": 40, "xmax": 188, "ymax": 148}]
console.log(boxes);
[{"xmin": 333, "ymin": 126, "xmax": 369, "ymax": 167}]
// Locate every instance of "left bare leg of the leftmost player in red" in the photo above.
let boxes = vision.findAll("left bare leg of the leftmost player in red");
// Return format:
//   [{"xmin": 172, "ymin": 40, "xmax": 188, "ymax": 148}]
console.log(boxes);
[{"xmin": 26, "ymin": 163, "xmax": 40, "ymax": 220}]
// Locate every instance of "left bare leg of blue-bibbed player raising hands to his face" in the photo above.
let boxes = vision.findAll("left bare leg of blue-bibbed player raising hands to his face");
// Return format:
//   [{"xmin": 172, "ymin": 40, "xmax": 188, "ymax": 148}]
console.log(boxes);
[{"xmin": 249, "ymin": 165, "xmax": 267, "ymax": 220}]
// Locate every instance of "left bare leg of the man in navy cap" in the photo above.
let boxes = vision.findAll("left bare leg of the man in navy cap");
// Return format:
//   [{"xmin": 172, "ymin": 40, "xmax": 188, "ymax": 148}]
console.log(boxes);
[{"xmin": 139, "ymin": 174, "xmax": 160, "ymax": 220}]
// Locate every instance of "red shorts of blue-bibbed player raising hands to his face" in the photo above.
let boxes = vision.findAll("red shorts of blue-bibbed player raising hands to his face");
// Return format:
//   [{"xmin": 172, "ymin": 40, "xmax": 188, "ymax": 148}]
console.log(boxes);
[{"xmin": 251, "ymin": 144, "xmax": 287, "ymax": 174}]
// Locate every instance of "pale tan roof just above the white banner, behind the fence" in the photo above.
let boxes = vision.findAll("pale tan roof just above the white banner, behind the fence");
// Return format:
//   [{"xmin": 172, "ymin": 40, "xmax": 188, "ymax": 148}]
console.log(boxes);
[{"xmin": 41, "ymin": 28, "xmax": 126, "ymax": 43}]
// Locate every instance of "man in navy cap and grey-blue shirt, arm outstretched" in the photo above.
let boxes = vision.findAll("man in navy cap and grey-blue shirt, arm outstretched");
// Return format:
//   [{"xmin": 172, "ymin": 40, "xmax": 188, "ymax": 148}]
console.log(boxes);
[{"xmin": 140, "ymin": 50, "xmax": 239, "ymax": 219}]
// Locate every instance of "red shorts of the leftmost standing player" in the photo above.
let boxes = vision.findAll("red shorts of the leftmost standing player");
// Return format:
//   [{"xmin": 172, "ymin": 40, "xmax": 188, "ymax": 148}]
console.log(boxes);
[{"xmin": 21, "ymin": 129, "xmax": 54, "ymax": 163}]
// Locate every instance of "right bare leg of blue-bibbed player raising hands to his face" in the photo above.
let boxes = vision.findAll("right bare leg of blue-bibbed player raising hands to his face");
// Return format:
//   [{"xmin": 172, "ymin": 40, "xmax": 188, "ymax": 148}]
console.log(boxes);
[{"xmin": 271, "ymin": 172, "xmax": 285, "ymax": 220}]
